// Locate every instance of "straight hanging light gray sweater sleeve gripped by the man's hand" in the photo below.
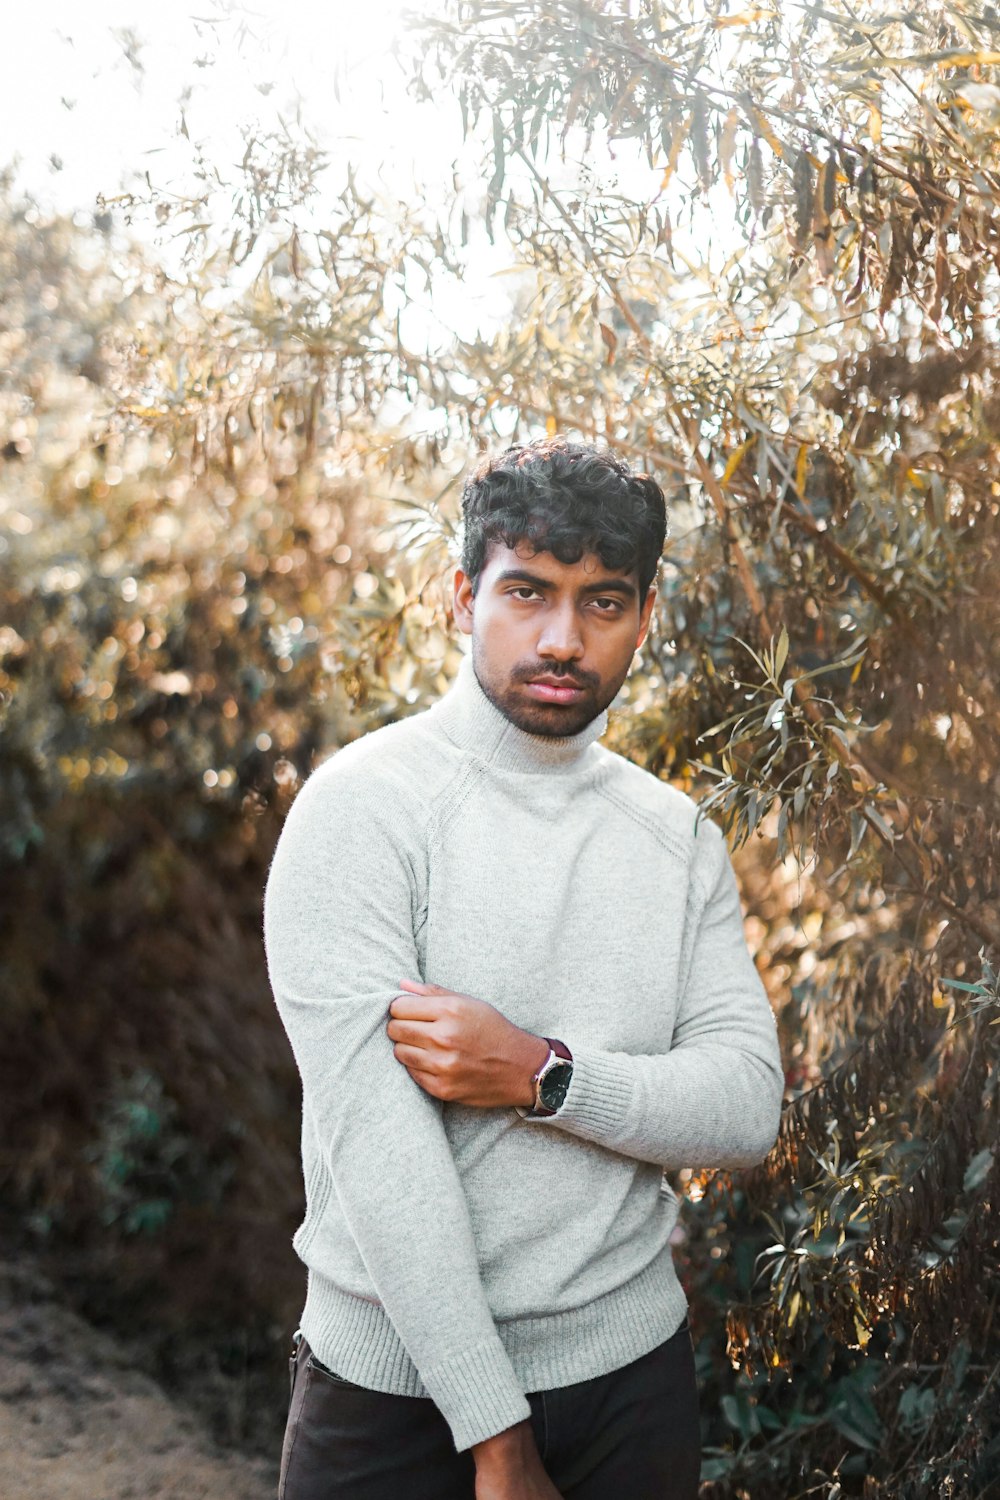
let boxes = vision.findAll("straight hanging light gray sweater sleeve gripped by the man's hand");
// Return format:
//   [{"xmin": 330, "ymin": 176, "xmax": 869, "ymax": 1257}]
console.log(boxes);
[{"xmin": 264, "ymin": 762, "xmax": 531, "ymax": 1452}]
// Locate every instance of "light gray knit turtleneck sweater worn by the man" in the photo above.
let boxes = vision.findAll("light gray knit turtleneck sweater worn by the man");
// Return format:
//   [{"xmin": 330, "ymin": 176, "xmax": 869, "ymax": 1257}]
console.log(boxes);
[{"xmin": 264, "ymin": 656, "xmax": 783, "ymax": 1451}]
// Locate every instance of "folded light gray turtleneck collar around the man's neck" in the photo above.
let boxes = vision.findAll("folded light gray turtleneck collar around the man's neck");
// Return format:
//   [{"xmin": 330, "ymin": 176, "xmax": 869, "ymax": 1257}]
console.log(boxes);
[{"xmin": 430, "ymin": 656, "xmax": 607, "ymax": 773}]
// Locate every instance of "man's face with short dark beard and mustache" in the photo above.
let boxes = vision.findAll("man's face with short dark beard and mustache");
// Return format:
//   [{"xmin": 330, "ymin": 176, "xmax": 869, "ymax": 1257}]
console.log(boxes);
[{"xmin": 454, "ymin": 542, "xmax": 655, "ymax": 735}]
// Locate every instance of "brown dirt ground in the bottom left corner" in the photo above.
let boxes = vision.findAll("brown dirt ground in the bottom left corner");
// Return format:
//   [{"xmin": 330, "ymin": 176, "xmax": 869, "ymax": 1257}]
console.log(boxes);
[{"xmin": 0, "ymin": 1265, "xmax": 277, "ymax": 1500}]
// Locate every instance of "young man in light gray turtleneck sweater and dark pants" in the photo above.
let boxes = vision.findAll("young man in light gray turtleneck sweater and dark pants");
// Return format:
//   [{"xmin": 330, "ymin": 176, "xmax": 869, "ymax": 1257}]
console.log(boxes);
[{"xmin": 264, "ymin": 440, "xmax": 783, "ymax": 1500}]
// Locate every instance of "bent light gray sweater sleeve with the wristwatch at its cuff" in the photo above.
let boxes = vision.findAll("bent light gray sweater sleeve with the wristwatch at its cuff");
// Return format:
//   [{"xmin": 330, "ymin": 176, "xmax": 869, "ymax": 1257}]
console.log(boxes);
[{"xmin": 532, "ymin": 822, "xmax": 784, "ymax": 1170}]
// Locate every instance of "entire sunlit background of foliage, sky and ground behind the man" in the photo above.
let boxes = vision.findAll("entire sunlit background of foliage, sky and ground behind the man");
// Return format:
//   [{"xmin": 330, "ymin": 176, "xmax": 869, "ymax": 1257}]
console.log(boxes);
[{"xmin": 0, "ymin": 0, "xmax": 1000, "ymax": 1500}]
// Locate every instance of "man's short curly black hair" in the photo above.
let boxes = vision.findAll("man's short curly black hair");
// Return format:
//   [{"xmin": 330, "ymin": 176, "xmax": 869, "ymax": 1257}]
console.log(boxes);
[{"xmin": 462, "ymin": 437, "xmax": 667, "ymax": 603}]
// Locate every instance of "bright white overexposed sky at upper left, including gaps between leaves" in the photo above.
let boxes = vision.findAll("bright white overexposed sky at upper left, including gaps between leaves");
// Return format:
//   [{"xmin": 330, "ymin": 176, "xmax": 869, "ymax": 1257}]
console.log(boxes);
[{"xmin": 7, "ymin": 0, "xmax": 746, "ymax": 373}]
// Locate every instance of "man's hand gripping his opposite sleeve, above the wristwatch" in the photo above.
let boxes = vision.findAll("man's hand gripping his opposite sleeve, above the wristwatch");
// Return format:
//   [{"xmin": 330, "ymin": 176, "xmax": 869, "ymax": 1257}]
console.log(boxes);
[{"xmin": 385, "ymin": 980, "xmax": 549, "ymax": 1109}]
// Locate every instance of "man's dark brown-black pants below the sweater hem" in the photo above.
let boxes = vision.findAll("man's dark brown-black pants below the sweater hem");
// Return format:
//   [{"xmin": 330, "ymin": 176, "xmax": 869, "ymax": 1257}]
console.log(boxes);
[{"xmin": 277, "ymin": 1317, "xmax": 702, "ymax": 1500}]
